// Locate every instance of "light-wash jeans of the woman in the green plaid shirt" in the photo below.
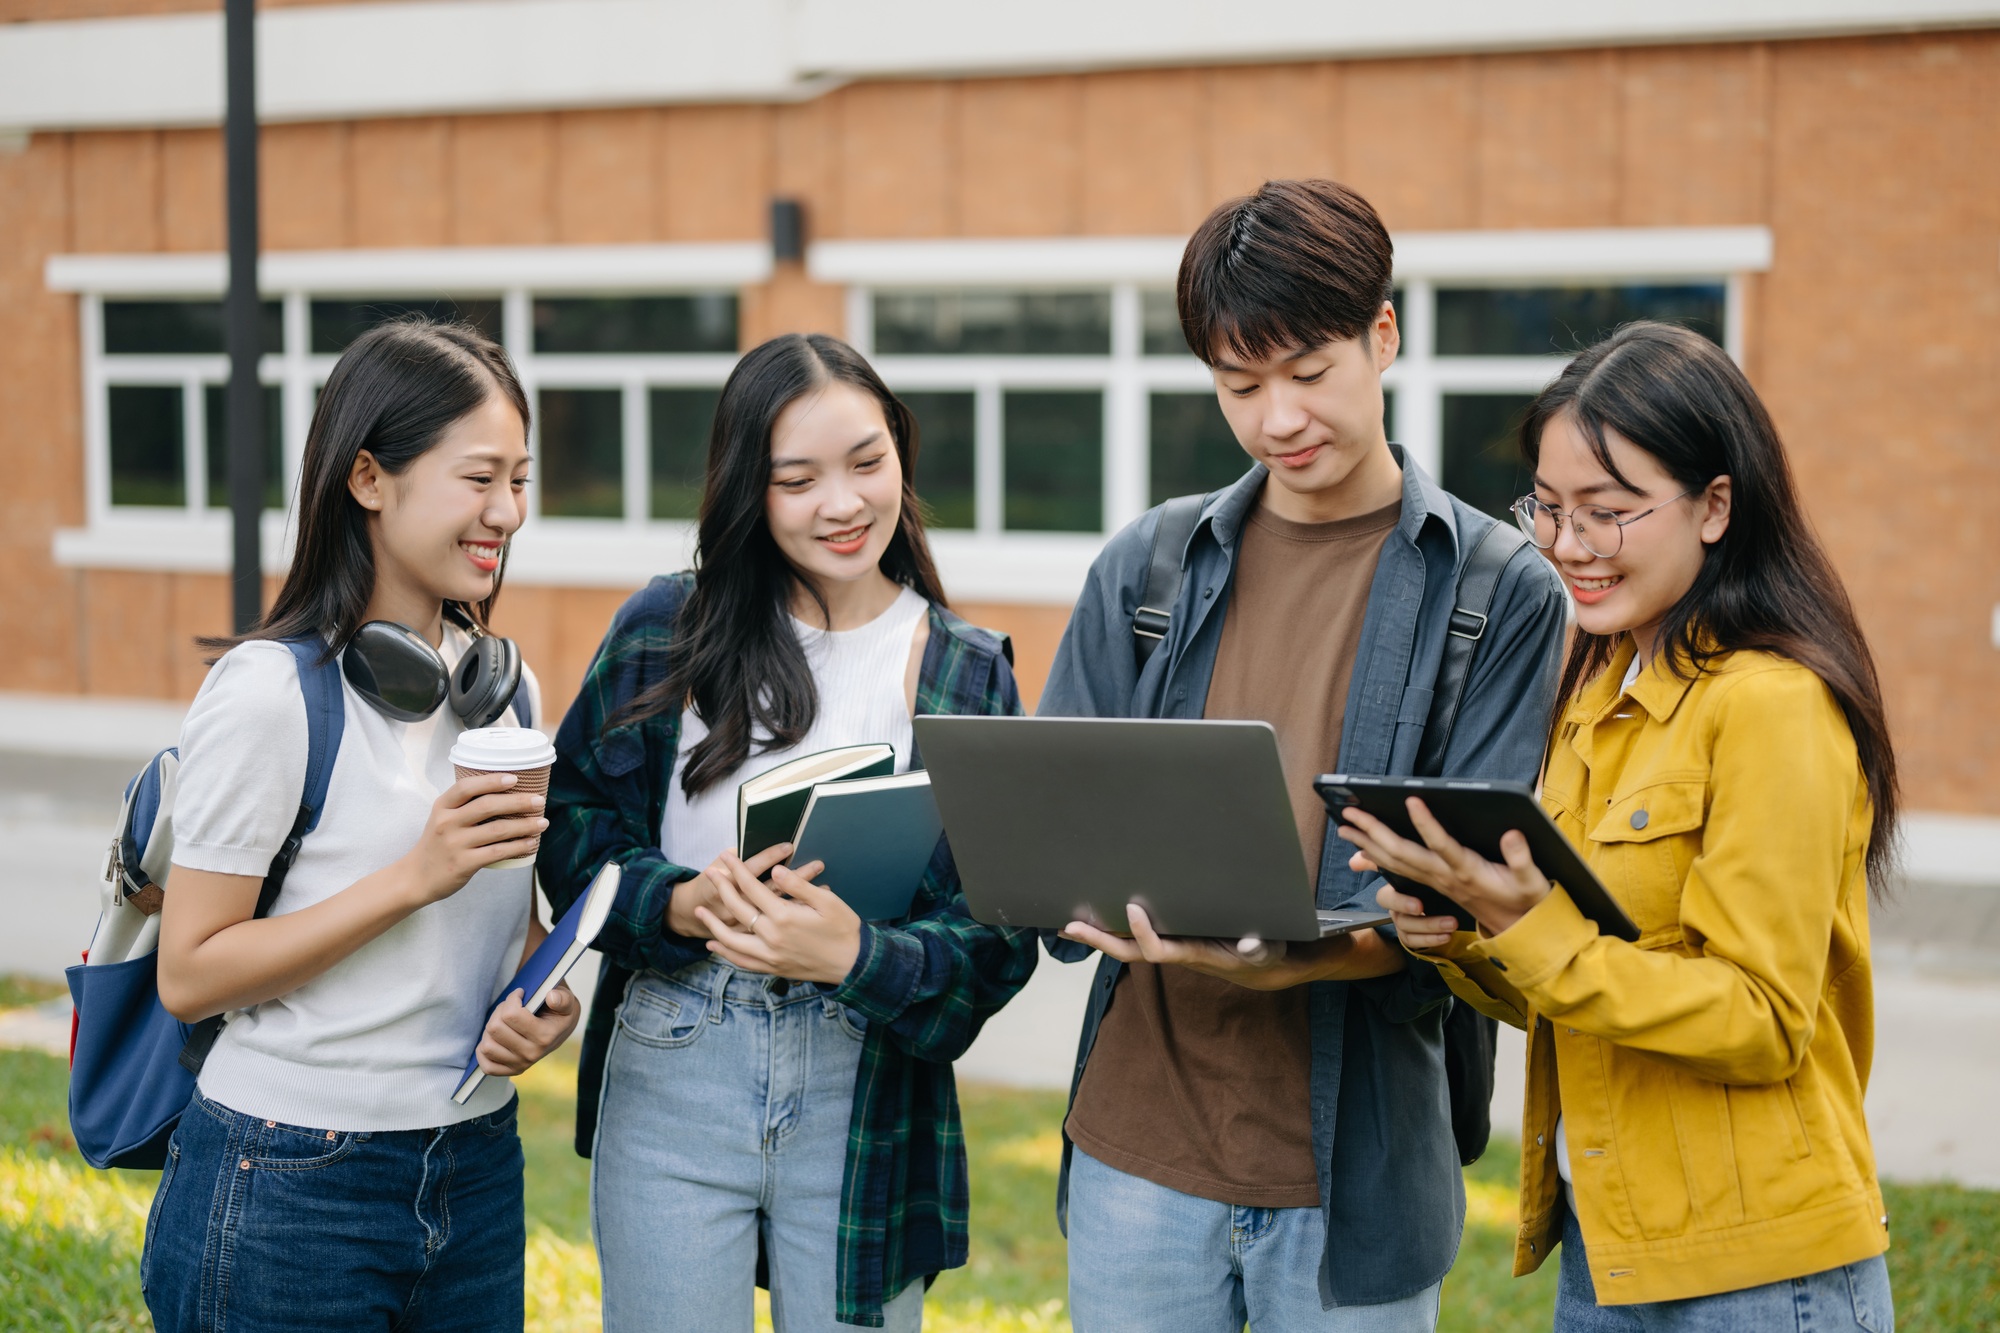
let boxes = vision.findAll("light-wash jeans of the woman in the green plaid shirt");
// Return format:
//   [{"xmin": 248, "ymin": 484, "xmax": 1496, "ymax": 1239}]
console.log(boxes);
[{"xmin": 590, "ymin": 961, "xmax": 924, "ymax": 1333}]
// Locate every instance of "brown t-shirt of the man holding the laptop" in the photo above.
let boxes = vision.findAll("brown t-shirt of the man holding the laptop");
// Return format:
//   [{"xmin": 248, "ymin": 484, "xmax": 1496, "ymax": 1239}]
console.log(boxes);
[{"xmin": 1068, "ymin": 502, "xmax": 1402, "ymax": 1209}]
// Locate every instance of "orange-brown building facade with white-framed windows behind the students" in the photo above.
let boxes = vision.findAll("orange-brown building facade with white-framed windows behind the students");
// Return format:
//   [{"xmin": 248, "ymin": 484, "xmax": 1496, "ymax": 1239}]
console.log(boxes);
[{"xmin": 0, "ymin": 0, "xmax": 2000, "ymax": 815}]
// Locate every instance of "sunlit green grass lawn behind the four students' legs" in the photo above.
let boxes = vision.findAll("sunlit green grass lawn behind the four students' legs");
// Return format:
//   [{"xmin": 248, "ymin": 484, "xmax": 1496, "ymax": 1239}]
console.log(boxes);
[{"xmin": 0, "ymin": 1051, "xmax": 2000, "ymax": 1333}]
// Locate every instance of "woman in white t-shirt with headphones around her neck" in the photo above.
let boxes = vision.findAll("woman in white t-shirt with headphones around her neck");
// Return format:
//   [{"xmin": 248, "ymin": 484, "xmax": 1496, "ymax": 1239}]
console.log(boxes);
[{"xmin": 140, "ymin": 320, "xmax": 578, "ymax": 1333}]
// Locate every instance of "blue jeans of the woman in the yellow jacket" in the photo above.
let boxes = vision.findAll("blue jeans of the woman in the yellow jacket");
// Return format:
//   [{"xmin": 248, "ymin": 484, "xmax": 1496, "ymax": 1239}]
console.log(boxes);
[{"xmin": 1554, "ymin": 1209, "xmax": 1896, "ymax": 1333}]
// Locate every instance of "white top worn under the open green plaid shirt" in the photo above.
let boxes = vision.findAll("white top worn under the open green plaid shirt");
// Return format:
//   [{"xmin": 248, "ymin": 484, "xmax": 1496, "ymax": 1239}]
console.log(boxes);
[{"xmin": 660, "ymin": 588, "xmax": 930, "ymax": 871}]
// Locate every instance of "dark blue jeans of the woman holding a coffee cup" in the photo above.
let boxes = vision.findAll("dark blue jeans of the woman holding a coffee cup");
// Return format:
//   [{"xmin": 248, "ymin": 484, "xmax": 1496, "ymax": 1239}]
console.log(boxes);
[{"xmin": 138, "ymin": 1093, "xmax": 528, "ymax": 1333}]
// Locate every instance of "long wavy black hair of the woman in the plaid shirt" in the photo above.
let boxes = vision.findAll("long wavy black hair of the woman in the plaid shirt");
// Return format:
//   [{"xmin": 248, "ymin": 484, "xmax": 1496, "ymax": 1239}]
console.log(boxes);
[{"xmin": 608, "ymin": 334, "xmax": 944, "ymax": 797}]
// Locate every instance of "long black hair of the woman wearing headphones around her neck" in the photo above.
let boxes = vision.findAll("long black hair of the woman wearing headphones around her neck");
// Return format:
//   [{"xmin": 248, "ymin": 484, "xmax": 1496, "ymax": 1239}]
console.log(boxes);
[{"xmin": 200, "ymin": 314, "xmax": 528, "ymax": 660}]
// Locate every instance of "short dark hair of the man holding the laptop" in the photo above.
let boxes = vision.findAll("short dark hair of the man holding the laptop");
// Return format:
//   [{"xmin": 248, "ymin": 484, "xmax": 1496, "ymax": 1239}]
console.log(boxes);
[{"xmin": 1174, "ymin": 180, "xmax": 1396, "ymax": 364}]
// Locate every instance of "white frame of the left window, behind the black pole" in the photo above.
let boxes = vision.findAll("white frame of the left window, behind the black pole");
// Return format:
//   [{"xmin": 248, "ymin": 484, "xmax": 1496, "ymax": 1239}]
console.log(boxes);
[{"xmin": 46, "ymin": 244, "xmax": 772, "ymax": 586}]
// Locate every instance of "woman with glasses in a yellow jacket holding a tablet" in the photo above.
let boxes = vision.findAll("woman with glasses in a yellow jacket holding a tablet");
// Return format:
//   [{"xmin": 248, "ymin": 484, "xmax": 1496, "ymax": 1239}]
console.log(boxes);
[{"xmin": 1340, "ymin": 324, "xmax": 1896, "ymax": 1333}]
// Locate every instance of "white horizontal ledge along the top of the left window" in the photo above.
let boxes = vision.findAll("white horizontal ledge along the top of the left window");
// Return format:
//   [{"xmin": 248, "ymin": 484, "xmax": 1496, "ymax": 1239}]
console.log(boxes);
[{"xmin": 46, "ymin": 240, "xmax": 772, "ymax": 296}]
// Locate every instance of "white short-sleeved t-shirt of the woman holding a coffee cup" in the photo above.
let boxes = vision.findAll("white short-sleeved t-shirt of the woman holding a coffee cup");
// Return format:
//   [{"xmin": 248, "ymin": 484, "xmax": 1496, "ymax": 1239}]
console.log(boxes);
[{"xmin": 168, "ymin": 628, "xmax": 542, "ymax": 1131}]
